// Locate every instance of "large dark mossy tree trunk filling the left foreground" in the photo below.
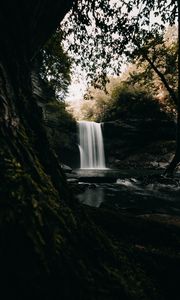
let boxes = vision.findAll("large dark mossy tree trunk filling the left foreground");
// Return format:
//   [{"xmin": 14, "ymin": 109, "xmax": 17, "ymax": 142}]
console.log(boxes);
[{"xmin": 0, "ymin": 0, "xmax": 78, "ymax": 299}]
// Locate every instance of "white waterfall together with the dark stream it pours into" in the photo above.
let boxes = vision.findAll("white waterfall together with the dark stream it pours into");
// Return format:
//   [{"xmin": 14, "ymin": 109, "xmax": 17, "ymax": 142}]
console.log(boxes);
[{"xmin": 76, "ymin": 121, "xmax": 180, "ymax": 217}]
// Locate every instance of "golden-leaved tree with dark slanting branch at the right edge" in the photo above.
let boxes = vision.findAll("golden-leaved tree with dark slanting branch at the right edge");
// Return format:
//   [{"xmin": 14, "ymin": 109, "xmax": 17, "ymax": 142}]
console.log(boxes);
[{"xmin": 129, "ymin": 28, "xmax": 178, "ymax": 105}]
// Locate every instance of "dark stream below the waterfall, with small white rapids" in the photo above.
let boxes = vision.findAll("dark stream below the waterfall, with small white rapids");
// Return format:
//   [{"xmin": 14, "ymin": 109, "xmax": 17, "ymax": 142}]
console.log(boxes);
[{"xmin": 76, "ymin": 170, "xmax": 180, "ymax": 216}]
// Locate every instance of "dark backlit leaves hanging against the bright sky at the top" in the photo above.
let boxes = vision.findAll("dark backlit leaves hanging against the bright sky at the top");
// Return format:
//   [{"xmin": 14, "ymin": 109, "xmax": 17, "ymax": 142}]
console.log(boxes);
[{"xmin": 63, "ymin": 0, "xmax": 178, "ymax": 86}]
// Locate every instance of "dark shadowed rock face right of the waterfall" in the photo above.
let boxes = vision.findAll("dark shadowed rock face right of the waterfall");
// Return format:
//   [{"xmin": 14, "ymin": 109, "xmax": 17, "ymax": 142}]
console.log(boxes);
[{"xmin": 103, "ymin": 119, "xmax": 176, "ymax": 168}]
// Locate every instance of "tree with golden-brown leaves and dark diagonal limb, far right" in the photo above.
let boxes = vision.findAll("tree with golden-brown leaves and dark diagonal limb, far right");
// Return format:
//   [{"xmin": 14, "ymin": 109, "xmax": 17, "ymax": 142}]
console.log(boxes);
[{"xmin": 123, "ymin": 26, "xmax": 178, "ymax": 116}]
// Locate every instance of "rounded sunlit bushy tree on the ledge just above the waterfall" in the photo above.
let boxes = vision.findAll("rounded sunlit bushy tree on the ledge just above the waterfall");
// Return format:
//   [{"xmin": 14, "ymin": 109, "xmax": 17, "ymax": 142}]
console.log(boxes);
[{"xmin": 80, "ymin": 77, "xmax": 168, "ymax": 122}]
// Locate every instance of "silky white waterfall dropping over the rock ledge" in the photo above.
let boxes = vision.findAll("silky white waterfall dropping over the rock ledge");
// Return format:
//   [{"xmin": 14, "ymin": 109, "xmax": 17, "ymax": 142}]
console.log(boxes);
[{"xmin": 78, "ymin": 121, "xmax": 106, "ymax": 169}]
